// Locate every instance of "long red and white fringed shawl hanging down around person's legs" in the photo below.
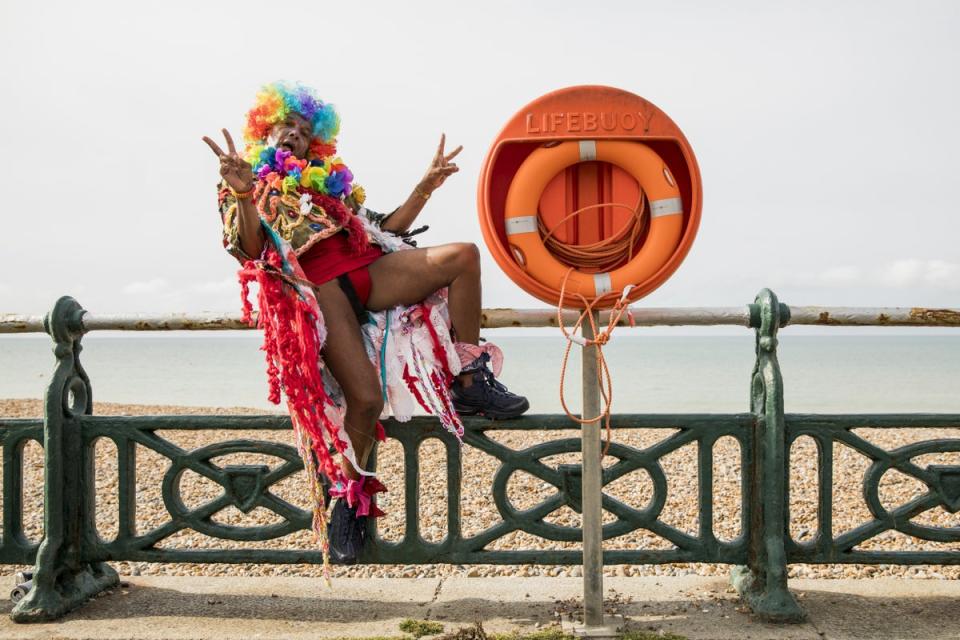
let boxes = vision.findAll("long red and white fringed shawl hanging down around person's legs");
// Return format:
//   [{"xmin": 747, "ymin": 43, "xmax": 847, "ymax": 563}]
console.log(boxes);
[{"xmin": 239, "ymin": 216, "xmax": 463, "ymax": 583}]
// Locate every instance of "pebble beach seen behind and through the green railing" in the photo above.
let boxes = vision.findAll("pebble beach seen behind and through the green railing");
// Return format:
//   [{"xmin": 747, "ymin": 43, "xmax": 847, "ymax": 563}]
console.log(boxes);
[{"xmin": 0, "ymin": 399, "xmax": 960, "ymax": 578}]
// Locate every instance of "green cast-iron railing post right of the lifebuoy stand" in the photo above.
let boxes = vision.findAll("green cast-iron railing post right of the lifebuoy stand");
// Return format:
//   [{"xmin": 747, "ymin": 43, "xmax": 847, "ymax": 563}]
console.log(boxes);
[{"xmin": 731, "ymin": 289, "xmax": 805, "ymax": 622}]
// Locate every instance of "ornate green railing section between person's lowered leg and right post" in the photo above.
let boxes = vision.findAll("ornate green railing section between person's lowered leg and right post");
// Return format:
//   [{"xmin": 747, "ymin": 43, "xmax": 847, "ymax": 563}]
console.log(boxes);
[{"xmin": 372, "ymin": 414, "xmax": 752, "ymax": 564}]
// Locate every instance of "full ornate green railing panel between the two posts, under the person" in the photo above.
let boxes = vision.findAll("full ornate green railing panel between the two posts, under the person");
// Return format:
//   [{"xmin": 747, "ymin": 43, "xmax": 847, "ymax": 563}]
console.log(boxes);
[{"xmin": 73, "ymin": 414, "xmax": 753, "ymax": 564}]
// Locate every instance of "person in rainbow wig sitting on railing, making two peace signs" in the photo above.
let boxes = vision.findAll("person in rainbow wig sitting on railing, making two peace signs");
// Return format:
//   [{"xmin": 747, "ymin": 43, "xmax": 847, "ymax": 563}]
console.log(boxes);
[{"xmin": 203, "ymin": 82, "xmax": 529, "ymax": 565}]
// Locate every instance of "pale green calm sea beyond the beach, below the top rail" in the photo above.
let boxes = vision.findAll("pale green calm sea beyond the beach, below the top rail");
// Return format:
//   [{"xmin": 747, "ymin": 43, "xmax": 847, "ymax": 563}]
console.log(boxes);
[{"xmin": 0, "ymin": 327, "xmax": 960, "ymax": 413}]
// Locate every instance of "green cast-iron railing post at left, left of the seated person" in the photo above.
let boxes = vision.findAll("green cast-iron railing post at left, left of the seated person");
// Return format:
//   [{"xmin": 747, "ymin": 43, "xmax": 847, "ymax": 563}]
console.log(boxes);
[{"xmin": 10, "ymin": 296, "xmax": 119, "ymax": 622}]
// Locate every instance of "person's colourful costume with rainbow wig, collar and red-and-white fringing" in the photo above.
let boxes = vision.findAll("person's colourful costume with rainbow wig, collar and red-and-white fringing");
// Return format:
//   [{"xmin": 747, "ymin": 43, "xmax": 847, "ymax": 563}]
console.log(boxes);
[{"xmin": 219, "ymin": 84, "xmax": 472, "ymax": 575}]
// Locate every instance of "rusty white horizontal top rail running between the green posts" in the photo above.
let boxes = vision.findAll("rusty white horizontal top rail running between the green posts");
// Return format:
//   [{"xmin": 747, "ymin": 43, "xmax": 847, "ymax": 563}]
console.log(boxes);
[{"xmin": 0, "ymin": 304, "xmax": 960, "ymax": 333}]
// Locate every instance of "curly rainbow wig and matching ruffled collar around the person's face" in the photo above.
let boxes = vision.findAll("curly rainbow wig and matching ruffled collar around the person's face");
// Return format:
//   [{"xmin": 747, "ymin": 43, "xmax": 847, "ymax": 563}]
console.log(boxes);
[{"xmin": 243, "ymin": 82, "xmax": 353, "ymax": 197}]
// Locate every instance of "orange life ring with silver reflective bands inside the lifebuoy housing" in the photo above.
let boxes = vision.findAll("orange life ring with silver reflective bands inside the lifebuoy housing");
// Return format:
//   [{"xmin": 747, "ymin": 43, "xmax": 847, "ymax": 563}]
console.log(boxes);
[{"xmin": 504, "ymin": 140, "xmax": 683, "ymax": 299}]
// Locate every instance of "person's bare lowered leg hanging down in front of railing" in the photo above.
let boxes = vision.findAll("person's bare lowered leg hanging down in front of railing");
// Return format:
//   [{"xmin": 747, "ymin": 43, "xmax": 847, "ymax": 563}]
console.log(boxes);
[{"xmin": 314, "ymin": 280, "xmax": 383, "ymax": 480}]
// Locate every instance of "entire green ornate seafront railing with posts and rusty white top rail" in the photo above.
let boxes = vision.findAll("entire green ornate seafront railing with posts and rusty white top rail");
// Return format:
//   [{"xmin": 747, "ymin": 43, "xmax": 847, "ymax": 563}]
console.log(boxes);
[{"xmin": 0, "ymin": 289, "xmax": 960, "ymax": 622}]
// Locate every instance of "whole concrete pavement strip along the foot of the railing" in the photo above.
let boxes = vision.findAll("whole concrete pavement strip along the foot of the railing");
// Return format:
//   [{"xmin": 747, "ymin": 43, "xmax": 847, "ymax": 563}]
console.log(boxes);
[{"xmin": 0, "ymin": 576, "xmax": 960, "ymax": 640}]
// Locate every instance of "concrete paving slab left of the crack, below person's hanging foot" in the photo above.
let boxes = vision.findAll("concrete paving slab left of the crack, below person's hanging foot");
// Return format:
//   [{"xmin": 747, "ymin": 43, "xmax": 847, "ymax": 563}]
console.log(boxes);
[{"xmin": 0, "ymin": 576, "xmax": 440, "ymax": 640}]
